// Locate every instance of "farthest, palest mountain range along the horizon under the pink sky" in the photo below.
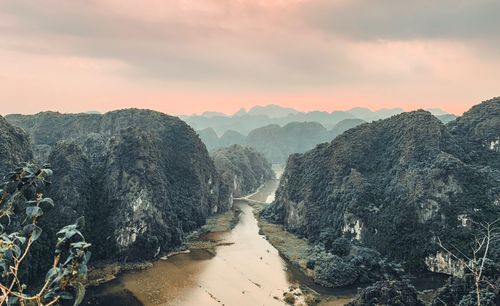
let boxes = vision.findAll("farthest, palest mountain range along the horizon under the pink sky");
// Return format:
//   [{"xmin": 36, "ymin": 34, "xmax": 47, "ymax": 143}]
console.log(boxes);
[{"xmin": 181, "ymin": 104, "xmax": 456, "ymax": 135}]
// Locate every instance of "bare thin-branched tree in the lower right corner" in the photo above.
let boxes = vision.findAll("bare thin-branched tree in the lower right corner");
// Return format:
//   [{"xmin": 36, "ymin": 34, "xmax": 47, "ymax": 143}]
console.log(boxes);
[{"xmin": 437, "ymin": 218, "xmax": 500, "ymax": 306}]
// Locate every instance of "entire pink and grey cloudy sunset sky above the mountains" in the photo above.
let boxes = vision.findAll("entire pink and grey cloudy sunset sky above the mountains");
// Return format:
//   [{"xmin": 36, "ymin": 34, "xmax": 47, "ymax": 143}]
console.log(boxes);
[{"xmin": 0, "ymin": 0, "xmax": 500, "ymax": 115}]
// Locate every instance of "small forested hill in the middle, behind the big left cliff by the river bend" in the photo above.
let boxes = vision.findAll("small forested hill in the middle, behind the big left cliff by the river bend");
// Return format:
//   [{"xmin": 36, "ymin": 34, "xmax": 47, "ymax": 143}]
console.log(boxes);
[{"xmin": 212, "ymin": 145, "xmax": 274, "ymax": 197}]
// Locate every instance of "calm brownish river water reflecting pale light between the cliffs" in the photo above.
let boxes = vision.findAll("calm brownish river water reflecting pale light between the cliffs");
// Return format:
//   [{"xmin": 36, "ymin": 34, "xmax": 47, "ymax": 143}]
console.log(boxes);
[{"xmin": 86, "ymin": 169, "xmax": 446, "ymax": 306}]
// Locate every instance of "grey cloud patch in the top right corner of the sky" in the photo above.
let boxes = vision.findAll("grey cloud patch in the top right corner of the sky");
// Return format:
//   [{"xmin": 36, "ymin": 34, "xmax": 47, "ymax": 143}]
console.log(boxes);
[{"xmin": 300, "ymin": 0, "xmax": 500, "ymax": 43}]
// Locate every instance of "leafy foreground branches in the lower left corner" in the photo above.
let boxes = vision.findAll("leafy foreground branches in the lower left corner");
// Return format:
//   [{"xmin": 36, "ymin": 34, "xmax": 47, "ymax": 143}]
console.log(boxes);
[{"xmin": 0, "ymin": 163, "xmax": 90, "ymax": 306}]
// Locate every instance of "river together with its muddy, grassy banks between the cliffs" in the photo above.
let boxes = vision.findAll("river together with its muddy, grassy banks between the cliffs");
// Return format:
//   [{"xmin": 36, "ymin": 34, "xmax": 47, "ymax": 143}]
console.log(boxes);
[{"xmin": 85, "ymin": 166, "xmax": 446, "ymax": 306}]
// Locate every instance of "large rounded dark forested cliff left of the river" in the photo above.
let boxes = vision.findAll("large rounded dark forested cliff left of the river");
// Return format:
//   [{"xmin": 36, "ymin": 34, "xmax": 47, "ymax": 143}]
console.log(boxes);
[{"xmin": 4, "ymin": 109, "xmax": 232, "ymax": 260}]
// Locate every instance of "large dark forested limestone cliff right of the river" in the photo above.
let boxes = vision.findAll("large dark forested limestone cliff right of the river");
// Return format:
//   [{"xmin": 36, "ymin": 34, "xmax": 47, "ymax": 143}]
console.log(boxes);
[{"xmin": 264, "ymin": 100, "xmax": 500, "ymax": 269}]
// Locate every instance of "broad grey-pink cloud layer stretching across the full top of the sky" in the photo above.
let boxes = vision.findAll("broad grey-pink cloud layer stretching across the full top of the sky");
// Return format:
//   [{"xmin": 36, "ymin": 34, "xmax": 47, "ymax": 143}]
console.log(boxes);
[{"xmin": 0, "ymin": 0, "xmax": 500, "ymax": 91}]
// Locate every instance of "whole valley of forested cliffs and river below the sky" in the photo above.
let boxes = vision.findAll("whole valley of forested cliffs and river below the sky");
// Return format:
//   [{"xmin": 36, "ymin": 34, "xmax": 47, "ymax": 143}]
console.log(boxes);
[{"xmin": 0, "ymin": 98, "xmax": 500, "ymax": 306}]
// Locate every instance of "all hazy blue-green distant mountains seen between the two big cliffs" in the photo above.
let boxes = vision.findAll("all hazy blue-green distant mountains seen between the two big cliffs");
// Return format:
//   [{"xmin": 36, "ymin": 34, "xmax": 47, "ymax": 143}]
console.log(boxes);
[{"xmin": 193, "ymin": 105, "xmax": 456, "ymax": 164}]
